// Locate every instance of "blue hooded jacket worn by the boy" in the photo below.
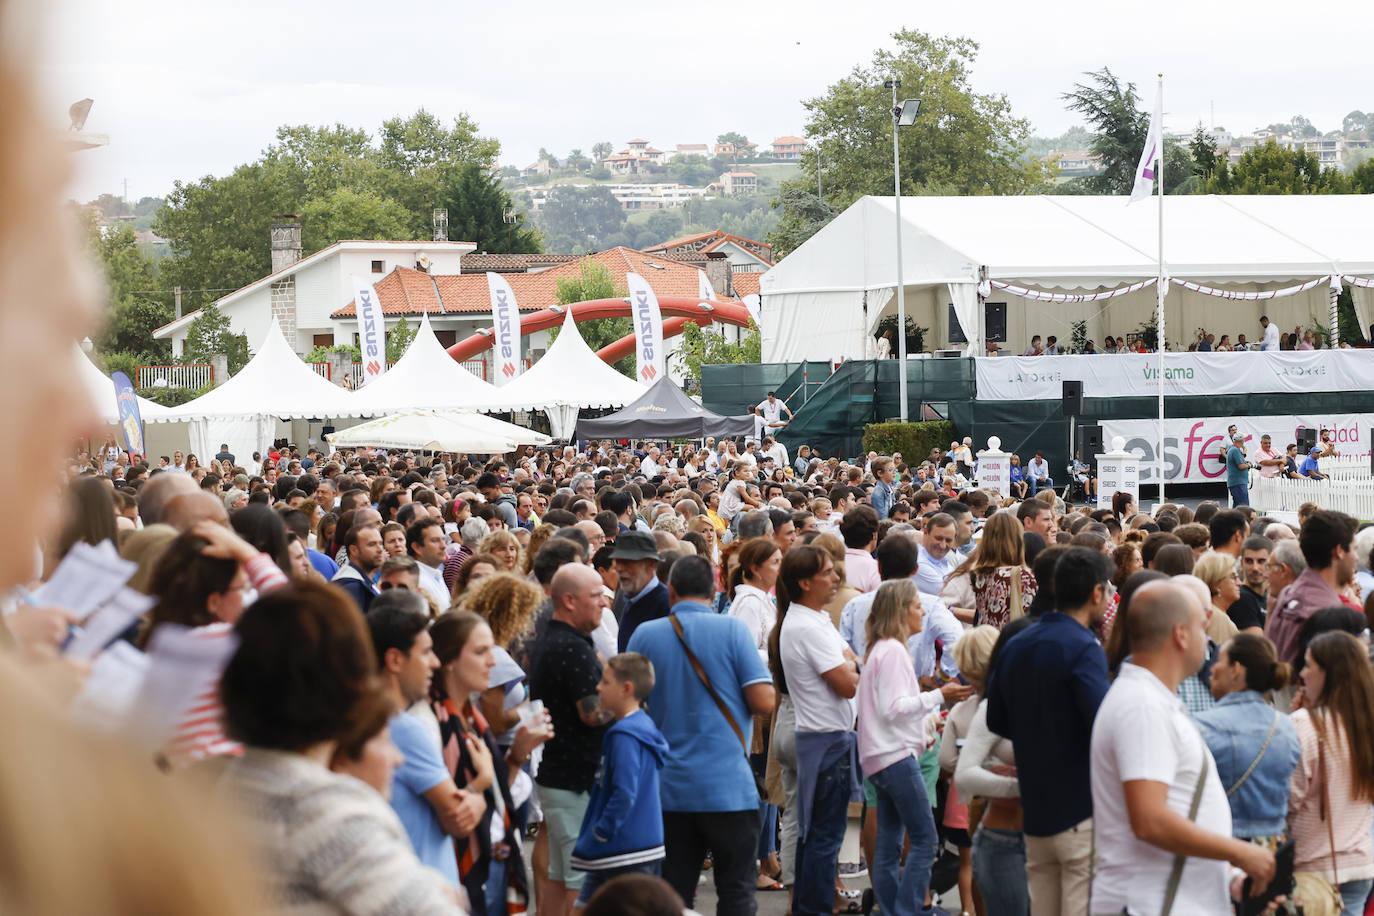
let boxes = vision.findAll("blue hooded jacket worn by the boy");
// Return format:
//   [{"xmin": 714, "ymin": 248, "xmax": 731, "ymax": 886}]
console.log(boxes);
[{"xmin": 572, "ymin": 710, "xmax": 668, "ymax": 872}]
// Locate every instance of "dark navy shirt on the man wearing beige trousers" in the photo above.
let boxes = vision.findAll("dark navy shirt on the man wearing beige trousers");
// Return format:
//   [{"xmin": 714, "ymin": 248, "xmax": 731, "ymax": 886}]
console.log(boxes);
[{"xmin": 988, "ymin": 611, "xmax": 1109, "ymax": 836}]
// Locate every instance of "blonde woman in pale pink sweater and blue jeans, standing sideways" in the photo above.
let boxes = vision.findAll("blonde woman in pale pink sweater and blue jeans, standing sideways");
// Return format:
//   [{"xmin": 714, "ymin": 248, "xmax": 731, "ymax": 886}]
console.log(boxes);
[{"xmin": 857, "ymin": 578, "xmax": 967, "ymax": 913}]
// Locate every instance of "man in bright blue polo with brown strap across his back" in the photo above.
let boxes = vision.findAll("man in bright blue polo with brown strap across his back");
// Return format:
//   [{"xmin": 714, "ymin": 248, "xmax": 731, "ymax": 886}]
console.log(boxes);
[{"xmin": 629, "ymin": 556, "xmax": 774, "ymax": 916}]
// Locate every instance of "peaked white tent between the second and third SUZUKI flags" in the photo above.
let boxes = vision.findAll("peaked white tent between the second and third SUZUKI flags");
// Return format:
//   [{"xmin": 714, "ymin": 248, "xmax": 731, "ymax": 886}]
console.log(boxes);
[{"xmin": 485, "ymin": 310, "xmax": 644, "ymax": 439}]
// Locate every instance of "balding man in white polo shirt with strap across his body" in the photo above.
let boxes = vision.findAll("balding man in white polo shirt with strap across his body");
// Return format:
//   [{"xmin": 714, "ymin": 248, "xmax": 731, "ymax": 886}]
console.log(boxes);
[{"xmin": 1091, "ymin": 582, "xmax": 1275, "ymax": 916}]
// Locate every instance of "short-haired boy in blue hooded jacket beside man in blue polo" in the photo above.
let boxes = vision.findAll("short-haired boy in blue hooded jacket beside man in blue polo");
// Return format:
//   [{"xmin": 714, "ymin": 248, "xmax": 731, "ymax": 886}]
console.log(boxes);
[{"xmin": 573, "ymin": 652, "xmax": 668, "ymax": 908}]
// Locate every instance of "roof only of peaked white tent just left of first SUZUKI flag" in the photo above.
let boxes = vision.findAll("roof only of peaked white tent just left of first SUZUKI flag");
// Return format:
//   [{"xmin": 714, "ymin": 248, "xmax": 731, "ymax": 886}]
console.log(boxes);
[{"xmin": 154, "ymin": 321, "xmax": 360, "ymax": 423}]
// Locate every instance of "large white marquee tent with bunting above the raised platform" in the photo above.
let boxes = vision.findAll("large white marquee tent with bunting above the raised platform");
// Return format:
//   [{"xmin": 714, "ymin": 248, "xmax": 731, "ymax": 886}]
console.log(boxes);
[{"xmin": 761, "ymin": 195, "xmax": 1374, "ymax": 363}]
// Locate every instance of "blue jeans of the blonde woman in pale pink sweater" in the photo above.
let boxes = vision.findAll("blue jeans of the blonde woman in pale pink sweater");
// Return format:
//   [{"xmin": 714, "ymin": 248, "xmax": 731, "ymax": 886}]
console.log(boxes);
[{"xmin": 868, "ymin": 757, "xmax": 936, "ymax": 916}]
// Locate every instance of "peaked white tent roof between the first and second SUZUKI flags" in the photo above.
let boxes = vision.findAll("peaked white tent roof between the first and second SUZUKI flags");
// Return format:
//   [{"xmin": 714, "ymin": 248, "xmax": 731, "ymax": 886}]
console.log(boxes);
[{"xmin": 352, "ymin": 316, "xmax": 496, "ymax": 416}]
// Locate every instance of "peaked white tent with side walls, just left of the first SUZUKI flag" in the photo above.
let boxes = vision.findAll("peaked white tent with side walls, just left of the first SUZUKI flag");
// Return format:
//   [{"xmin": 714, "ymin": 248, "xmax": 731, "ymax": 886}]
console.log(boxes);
[{"xmin": 150, "ymin": 321, "xmax": 359, "ymax": 466}]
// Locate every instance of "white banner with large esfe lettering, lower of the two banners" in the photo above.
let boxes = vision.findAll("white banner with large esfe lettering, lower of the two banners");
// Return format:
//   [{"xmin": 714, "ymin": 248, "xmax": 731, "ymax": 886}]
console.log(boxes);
[{"xmin": 1099, "ymin": 414, "xmax": 1374, "ymax": 485}]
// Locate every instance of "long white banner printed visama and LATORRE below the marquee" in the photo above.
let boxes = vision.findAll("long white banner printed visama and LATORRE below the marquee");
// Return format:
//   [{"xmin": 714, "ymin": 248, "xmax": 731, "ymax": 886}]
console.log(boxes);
[{"xmin": 976, "ymin": 350, "xmax": 1374, "ymax": 401}]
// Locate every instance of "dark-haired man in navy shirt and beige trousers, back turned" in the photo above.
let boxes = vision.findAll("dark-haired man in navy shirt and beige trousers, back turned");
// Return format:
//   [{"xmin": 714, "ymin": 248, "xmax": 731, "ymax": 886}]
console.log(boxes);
[{"xmin": 988, "ymin": 547, "xmax": 1113, "ymax": 916}]
